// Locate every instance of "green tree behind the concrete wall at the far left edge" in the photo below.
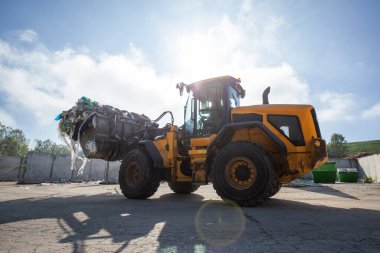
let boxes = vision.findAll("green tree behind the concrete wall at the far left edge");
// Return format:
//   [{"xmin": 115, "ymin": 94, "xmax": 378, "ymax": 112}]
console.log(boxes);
[{"xmin": 0, "ymin": 122, "xmax": 29, "ymax": 156}]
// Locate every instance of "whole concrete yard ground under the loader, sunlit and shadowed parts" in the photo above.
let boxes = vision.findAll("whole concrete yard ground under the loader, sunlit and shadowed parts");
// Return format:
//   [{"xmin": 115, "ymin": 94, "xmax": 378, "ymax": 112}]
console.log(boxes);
[{"xmin": 0, "ymin": 183, "xmax": 380, "ymax": 252}]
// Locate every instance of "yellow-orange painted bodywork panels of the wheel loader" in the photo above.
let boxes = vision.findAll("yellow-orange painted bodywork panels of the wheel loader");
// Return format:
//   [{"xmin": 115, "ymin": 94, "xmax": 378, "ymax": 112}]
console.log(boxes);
[{"xmin": 154, "ymin": 104, "xmax": 327, "ymax": 183}]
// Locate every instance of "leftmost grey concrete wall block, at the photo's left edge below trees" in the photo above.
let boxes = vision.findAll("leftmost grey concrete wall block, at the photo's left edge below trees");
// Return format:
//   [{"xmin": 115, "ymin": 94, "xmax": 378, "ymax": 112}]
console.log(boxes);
[{"xmin": 0, "ymin": 156, "xmax": 22, "ymax": 181}]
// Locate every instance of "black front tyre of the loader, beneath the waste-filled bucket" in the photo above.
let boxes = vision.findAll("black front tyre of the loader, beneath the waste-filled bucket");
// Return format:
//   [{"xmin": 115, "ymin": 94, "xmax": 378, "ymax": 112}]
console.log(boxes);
[{"xmin": 119, "ymin": 149, "xmax": 160, "ymax": 199}]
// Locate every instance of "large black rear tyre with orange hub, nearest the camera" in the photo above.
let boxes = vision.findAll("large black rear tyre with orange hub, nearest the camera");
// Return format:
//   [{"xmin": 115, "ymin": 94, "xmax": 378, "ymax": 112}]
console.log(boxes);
[{"xmin": 212, "ymin": 142, "xmax": 277, "ymax": 206}]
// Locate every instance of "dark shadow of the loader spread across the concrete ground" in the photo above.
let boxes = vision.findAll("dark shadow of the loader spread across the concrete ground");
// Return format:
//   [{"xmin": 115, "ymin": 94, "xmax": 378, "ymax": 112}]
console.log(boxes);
[{"xmin": 0, "ymin": 190, "xmax": 380, "ymax": 252}]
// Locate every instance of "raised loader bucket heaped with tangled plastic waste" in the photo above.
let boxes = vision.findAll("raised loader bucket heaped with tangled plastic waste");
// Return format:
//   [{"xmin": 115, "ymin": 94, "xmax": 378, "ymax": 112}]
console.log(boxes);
[{"xmin": 56, "ymin": 97, "xmax": 160, "ymax": 171}]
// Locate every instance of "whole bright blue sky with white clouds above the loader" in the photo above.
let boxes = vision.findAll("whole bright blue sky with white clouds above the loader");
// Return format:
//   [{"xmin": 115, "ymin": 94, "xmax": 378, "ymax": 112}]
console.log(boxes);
[{"xmin": 0, "ymin": 0, "xmax": 380, "ymax": 144}]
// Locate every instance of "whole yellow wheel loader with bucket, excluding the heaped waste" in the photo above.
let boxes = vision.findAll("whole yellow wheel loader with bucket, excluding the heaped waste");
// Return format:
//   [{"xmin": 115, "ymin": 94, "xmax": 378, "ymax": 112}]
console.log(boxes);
[{"xmin": 75, "ymin": 76, "xmax": 327, "ymax": 206}]
